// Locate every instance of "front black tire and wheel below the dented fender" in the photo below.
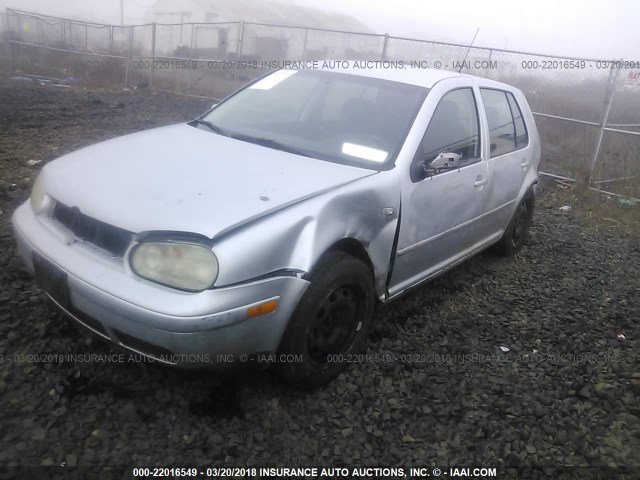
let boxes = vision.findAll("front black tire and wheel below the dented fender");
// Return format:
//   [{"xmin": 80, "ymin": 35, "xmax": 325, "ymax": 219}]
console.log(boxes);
[{"xmin": 276, "ymin": 252, "xmax": 375, "ymax": 389}]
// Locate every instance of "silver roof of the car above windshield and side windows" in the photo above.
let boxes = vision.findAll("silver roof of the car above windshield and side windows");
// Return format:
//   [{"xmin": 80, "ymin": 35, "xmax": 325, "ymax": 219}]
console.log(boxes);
[{"xmin": 314, "ymin": 60, "xmax": 513, "ymax": 89}]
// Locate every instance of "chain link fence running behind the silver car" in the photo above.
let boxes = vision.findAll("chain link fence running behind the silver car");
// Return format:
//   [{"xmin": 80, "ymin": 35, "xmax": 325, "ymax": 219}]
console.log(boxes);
[{"xmin": 0, "ymin": 9, "xmax": 640, "ymax": 198}]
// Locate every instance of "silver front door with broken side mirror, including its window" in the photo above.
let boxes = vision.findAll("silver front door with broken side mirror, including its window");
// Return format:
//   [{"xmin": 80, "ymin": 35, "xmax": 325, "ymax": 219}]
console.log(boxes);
[{"xmin": 389, "ymin": 78, "xmax": 489, "ymax": 295}]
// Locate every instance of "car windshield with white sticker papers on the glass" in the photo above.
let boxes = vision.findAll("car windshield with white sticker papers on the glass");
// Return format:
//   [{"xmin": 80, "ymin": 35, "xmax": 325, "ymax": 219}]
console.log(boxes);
[{"xmin": 200, "ymin": 70, "xmax": 428, "ymax": 169}]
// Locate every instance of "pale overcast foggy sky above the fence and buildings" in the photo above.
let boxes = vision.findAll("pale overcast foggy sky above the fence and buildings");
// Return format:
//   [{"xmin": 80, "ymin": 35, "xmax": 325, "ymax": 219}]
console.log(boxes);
[{"xmin": 0, "ymin": 0, "xmax": 640, "ymax": 60}]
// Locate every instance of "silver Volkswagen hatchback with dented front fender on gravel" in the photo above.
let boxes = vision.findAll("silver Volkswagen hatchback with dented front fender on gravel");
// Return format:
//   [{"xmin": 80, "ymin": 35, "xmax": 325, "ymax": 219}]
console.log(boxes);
[{"xmin": 13, "ymin": 63, "xmax": 540, "ymax": 387}]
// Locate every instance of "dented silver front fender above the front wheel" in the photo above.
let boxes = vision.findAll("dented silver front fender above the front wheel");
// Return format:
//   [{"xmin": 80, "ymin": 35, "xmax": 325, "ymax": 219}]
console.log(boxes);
[{"xmin": 213, "ymin": 170, "xmax": 400, "ymax": 299}]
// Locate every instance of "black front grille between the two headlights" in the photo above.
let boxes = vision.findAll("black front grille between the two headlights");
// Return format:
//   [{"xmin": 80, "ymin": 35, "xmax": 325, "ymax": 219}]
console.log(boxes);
[{"xmin": 53, "ymin": 202, "xmax": 133, "ymax": 257}]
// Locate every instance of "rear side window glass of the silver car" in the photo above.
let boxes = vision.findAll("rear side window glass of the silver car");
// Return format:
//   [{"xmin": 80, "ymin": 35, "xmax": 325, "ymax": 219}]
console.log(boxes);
[{"xmin": 480, "ymin": 88, "xmax": 529, "ymax": 158}]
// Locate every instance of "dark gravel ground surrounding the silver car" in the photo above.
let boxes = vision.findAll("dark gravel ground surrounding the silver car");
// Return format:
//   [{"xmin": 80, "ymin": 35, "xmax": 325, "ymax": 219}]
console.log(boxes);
[{"xmin": 0, "ymin": 80, "xmax": 640, "ymax": 466}]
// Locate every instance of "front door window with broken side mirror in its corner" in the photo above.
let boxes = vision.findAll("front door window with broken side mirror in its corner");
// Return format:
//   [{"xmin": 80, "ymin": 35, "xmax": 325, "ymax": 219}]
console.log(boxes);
[{"xmin": 411, "ymin": 88, "xmax": 480, "ymax": 182}]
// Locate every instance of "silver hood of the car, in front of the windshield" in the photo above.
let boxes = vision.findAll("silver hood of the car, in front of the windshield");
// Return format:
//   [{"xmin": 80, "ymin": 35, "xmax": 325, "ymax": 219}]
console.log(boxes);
[{"xmin": 43, "ymin": 124, "xmax": 376, "ymax": 238}]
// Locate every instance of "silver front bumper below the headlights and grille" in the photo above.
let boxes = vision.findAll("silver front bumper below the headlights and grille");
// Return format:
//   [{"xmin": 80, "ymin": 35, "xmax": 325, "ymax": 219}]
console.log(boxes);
[{"xmin": 12, "ymin": 202, "xmax": 309, "ymax": 367}]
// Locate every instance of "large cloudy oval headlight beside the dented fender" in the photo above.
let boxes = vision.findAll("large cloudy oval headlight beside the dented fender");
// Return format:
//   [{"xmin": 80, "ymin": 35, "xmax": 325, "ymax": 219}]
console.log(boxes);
[{"xmin": 130, "ymin": 240, "xmax": 218, "ymax": 292}]
